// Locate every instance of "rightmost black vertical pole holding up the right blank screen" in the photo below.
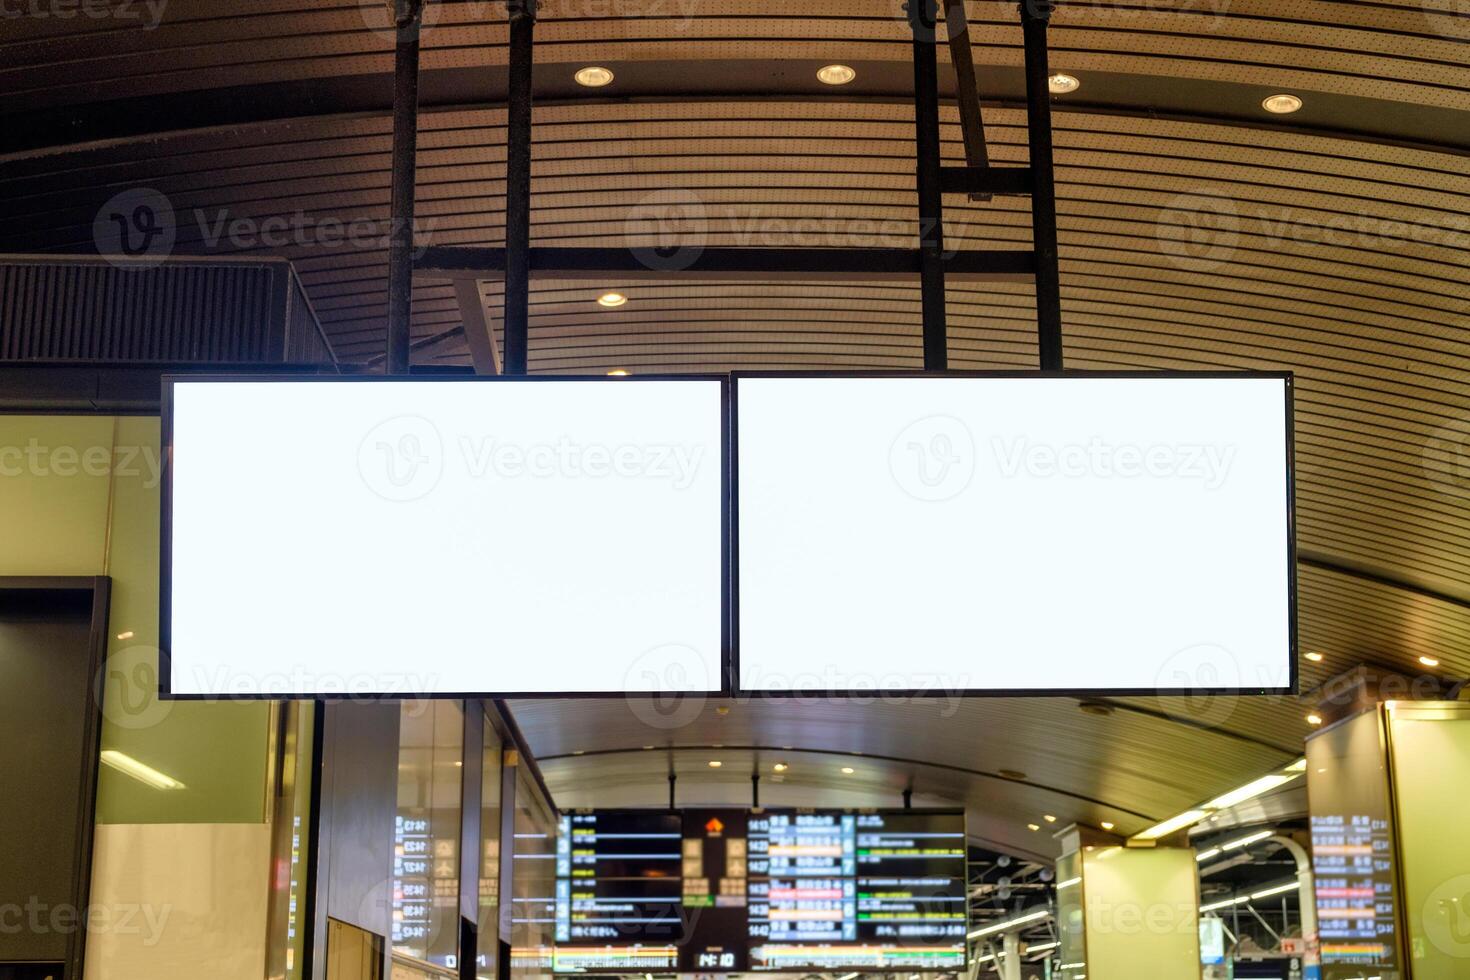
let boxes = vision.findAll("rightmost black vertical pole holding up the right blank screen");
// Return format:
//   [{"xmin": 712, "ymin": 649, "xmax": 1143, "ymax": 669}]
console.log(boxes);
[{"xmin": 1020, "ymin": 0, "xmax": 1061, "ymax": 370}]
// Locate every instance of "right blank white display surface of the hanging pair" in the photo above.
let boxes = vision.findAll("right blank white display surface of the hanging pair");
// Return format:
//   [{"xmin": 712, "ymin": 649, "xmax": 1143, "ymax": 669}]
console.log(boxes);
[{"xmin": 735, "ymin": 375, "xmax": 1294, "ymax": 693}]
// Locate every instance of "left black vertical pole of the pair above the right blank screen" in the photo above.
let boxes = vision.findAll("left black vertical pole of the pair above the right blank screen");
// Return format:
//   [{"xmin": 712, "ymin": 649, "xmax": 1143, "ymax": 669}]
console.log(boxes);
[{"xmin": 907, "ymin": 0, "xmax": 950, "ymax": 370}]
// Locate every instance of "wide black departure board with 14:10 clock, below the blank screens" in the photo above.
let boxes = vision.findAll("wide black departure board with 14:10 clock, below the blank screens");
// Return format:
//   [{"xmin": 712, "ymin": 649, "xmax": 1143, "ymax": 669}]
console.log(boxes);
[{"xmin": 554, "ymin": 810, "xmax": 967, "ymax": 973}]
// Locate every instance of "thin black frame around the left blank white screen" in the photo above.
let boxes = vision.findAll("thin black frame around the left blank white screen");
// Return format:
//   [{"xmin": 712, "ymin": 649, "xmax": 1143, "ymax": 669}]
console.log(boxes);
[{"xmin": 159, "ymin": 372, "xmax": 735, "ymax": 701}]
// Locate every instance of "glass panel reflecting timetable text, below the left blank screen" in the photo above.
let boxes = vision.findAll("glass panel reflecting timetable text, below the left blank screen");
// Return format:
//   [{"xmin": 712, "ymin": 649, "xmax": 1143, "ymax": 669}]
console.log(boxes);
[{"xmin": 392, "ymin": 701, "xmax": 465, "ymax": 970}]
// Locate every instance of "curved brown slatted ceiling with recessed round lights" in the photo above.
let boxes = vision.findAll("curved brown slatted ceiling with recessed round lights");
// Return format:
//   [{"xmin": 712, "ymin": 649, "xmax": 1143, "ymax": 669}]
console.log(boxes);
[{"xmin": 0, "ymin": 0, "xmax": 1470, "ymax": 855}]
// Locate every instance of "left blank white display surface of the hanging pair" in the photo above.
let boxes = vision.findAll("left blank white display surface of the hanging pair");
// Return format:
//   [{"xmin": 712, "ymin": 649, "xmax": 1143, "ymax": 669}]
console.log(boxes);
[{"xmin": 165, "ymin": 379, "xmax": 726, "ymax": 696}]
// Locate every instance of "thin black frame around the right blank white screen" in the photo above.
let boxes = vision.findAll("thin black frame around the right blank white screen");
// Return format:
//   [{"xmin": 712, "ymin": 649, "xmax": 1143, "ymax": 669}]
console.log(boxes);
[{"xmin": 728, "ymin": 370, "xmax": 1301, "ymax": 701}]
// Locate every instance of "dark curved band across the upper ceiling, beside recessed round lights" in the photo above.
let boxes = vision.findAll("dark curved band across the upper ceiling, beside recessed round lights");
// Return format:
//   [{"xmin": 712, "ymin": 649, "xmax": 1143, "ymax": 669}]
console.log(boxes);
[{"xmin": 0, "ymin": 59, "xmax": 1470, "ymax": 160}]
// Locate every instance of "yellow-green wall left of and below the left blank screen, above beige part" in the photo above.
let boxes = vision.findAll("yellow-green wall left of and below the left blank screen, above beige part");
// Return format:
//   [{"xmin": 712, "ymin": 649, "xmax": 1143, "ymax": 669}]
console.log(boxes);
[{"xmin": 0, "ymin": 416, "xmax": 270, "ymax": 823}]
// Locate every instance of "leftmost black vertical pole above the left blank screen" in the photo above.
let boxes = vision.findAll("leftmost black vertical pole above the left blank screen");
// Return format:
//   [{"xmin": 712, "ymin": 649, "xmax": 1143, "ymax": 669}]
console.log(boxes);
[{"xmin": 382, "ymin": 0, "xmax": 423, "ymax": 375}]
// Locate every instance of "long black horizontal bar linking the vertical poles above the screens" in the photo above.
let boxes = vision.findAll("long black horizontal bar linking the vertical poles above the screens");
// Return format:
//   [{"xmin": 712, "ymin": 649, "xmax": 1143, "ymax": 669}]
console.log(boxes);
[{"xmin": 415, "ymin": 244, "xmax": 1035, "ymax": 282}]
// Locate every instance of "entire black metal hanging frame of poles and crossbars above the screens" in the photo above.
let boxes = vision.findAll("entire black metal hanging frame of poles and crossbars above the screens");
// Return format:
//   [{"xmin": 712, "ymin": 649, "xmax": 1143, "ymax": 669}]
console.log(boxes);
[{"xmin": 385, "ymin": 0, "xmax": 1061, "ymax": 375}]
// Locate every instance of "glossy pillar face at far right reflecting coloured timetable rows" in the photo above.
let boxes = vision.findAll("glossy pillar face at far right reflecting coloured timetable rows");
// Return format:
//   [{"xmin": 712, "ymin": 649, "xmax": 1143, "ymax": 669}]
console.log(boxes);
[{"xmin": 1307, "ymin": 711, "xmax": 1402, "ymax": 980}]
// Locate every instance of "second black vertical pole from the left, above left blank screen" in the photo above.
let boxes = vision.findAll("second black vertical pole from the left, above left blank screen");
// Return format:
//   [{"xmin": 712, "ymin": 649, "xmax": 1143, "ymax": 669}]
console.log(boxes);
[{"xmin": 503, "ymin": 0, "xmax": 537, "ymax": 375}]
